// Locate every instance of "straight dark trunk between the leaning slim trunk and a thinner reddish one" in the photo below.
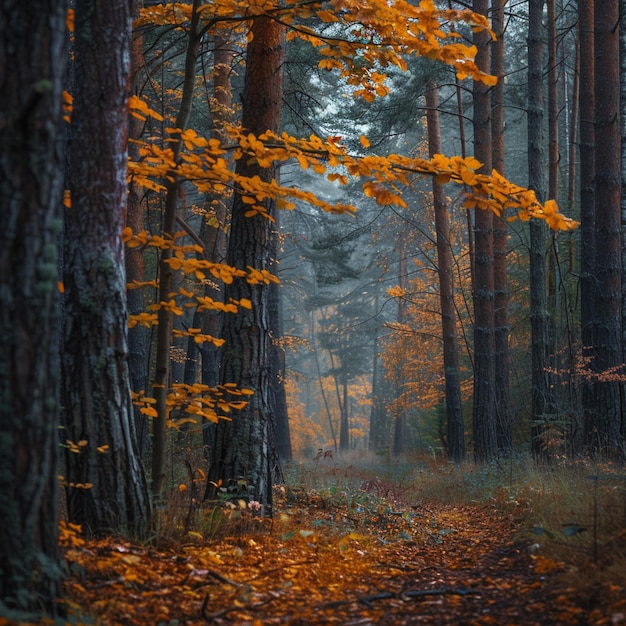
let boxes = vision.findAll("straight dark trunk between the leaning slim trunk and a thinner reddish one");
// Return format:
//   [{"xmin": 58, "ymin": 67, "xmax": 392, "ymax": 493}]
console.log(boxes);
[{"xmin": 473, "ymin": 0, "xmax": 498, "ymax": 461}]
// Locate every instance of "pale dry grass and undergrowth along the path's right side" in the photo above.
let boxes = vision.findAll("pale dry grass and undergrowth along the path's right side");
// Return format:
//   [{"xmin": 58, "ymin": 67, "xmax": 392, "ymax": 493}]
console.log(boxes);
[{"xmin": 287, "ymin": 448, "xmax": 626, "ymax": 595}]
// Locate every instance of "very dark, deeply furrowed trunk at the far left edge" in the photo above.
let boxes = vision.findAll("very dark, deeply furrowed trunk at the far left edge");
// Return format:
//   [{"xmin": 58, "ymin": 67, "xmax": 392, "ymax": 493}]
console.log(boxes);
[{"xmin": 0, "ymin": 0, "xmax": 65, "ymax": 623}]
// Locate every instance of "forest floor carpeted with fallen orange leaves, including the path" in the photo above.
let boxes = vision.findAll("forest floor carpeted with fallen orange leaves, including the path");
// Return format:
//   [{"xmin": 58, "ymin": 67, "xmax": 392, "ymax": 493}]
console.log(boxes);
[{"xmin": 65, "ymin": 492, "xmax": 626, "ymax": 626}]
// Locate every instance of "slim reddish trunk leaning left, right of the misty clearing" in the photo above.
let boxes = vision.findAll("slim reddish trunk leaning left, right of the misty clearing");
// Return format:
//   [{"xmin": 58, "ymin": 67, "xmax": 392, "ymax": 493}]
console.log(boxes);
[{"xmin": 426, "ymin": 80, "xmax": 465, "ymax": 463}]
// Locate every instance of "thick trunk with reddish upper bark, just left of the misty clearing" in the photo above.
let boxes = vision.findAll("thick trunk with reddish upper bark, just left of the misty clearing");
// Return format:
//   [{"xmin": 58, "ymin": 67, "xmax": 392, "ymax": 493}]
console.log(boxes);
[{"xmin": 208, "ymin": 16, "xmax": 285, "ymax": 514}]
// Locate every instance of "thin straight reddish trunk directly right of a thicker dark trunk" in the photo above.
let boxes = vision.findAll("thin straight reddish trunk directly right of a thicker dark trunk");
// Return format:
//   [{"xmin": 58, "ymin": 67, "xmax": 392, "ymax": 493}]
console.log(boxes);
[{"xmin": 491, "ymin": 0, "xmax": 513, "ymax": 452}]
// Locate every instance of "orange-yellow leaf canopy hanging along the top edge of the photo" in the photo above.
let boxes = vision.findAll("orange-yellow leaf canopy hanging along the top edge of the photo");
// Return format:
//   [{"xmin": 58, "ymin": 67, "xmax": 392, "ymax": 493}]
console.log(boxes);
[{"xmin": 135, "ymin": 0, "xmax": 495, "ymax": 100}]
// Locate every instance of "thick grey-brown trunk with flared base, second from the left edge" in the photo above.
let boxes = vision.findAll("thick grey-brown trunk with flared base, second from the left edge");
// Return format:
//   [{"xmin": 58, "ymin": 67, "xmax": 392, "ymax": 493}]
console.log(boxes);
[{"xmin": 63, "ymin": 0, "xmax": 150, "ymax": 536}]
